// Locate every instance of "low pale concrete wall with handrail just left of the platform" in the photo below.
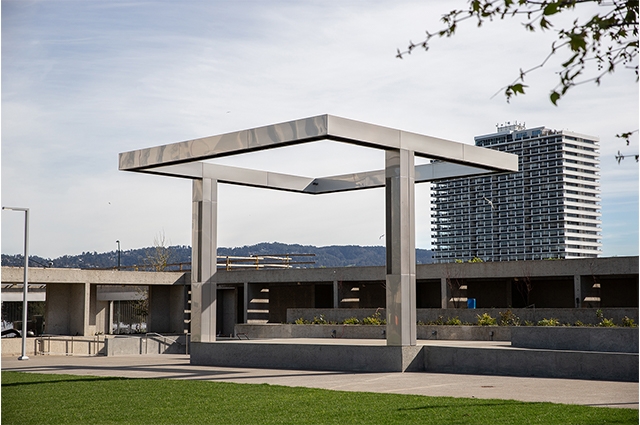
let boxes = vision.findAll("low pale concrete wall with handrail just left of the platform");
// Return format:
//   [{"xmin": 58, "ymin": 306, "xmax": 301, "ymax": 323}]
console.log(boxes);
[{"xmin": 105, "ymin": 335, "xmax": 188, "ymax": 356}]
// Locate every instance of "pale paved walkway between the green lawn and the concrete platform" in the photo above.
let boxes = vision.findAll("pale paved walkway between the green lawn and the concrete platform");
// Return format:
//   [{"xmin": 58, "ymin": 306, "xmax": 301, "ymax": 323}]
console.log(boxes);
[{"xmin": 2, "ymin": 354, "xmax": 638, "ymax": 409}]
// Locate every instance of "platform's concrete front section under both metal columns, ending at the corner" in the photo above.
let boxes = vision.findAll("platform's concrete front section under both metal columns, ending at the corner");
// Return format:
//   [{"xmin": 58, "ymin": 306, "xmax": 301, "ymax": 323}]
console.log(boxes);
[{"xmin": 191, "ymin": 341, "xmax": 424, "ymax": 372}]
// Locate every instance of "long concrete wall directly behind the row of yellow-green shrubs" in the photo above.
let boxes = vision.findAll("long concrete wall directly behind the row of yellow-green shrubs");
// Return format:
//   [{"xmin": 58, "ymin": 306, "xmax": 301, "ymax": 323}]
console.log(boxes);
[{"xmin": 287, "ymin": 308, "xmax": 639, "ymax": 325}]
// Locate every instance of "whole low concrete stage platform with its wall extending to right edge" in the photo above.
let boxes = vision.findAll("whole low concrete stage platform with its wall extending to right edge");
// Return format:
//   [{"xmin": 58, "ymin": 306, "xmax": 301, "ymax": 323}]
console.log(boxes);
[{"xmin": 190, "ymin": 338, "xmax": 638, "ymax": 382}]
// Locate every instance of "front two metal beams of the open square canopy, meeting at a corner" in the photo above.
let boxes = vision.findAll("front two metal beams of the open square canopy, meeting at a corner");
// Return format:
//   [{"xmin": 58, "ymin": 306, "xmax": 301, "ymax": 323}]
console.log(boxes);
[{"xmin": 119, "ymin": 115, "xmax": 518, "ymax": 175}]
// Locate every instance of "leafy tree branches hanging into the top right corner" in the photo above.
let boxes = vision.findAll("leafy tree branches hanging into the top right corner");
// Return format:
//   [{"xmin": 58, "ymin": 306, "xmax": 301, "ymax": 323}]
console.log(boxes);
[{"xmin": 396, "ymin": 0, "xmax": 638, "ymax": 105}]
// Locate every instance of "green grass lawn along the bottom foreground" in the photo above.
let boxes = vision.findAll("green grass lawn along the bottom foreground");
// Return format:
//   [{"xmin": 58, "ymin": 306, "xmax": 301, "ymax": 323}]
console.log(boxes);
[{"xmin": 2, "ymin": 372, "xmax": 638, "ymax": 425}]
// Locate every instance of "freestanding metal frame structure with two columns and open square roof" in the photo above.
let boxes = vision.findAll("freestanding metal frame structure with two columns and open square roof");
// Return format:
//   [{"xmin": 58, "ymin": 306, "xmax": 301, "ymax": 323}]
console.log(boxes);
[{"xmin": 119, "ymin": 115, "xmax": 518, "ymax": 347}]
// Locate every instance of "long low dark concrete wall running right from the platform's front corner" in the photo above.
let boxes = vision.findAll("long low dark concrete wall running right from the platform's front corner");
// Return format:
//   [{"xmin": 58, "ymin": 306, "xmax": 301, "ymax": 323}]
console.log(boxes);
[{"xmin": 424, "ymin": 346, "xmax": 638, "ymax": 382}]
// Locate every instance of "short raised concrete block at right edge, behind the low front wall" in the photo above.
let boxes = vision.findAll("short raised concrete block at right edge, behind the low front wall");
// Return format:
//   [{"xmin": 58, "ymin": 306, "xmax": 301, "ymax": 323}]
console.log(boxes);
[{"xmin": 511, "ymin": 326, "xmax": 639, "ymax": 354}]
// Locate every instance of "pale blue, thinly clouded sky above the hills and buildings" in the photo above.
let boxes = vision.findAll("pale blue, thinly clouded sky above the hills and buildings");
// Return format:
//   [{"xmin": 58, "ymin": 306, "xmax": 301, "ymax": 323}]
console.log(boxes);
[{"xmin": 2, "ymin": 0, "xmax": 638, "ymax": 258}]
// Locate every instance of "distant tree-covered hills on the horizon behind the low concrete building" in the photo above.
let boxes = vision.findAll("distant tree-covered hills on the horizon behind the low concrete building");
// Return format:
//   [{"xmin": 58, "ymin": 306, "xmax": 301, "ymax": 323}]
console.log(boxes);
[{"xmin": 2, "ymin": 242, "xmax": 431, "ymax": 269}]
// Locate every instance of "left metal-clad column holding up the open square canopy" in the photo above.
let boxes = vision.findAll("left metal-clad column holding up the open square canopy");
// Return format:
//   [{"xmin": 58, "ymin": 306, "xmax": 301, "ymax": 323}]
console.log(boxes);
[{"xmin": 191, "ymin": 178, "xmax": 218, "ymax": 342}]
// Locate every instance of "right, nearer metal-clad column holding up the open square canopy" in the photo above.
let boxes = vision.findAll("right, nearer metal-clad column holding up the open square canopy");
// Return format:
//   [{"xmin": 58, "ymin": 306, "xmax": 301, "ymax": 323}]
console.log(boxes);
[{"xmin": 385, "ymin": 149, "xmax": 417, "ymax": 346}]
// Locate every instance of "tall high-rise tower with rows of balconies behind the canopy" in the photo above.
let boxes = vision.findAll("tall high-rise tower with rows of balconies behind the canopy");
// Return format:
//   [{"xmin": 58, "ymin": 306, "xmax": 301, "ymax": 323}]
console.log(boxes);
[{"xmin": 432, "ymin": 123, "xmax": 602, "ymax": 263}]
